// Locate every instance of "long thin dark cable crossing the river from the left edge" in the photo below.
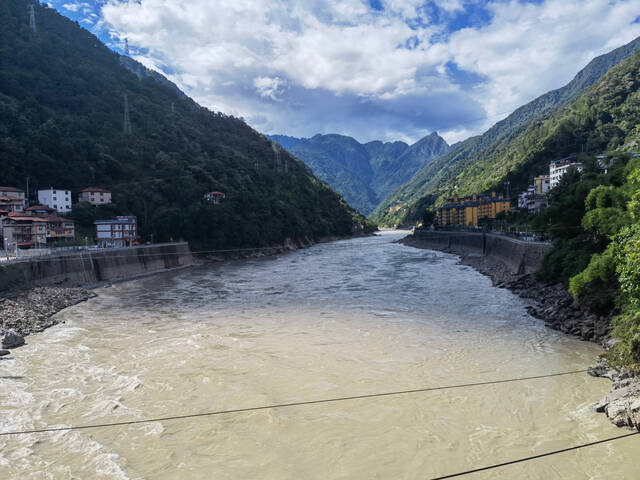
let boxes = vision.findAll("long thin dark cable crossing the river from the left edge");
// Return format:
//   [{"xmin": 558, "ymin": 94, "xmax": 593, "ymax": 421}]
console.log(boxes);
[{"xmin": 0, "ymin": 370, "xmax": 588, "ymax": 436}]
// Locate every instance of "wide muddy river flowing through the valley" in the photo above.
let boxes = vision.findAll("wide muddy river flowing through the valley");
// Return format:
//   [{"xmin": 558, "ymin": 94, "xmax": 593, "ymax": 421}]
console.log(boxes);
[{"xmin": 0, "ymin": 233, "xmax": 640, "ymax": 480}]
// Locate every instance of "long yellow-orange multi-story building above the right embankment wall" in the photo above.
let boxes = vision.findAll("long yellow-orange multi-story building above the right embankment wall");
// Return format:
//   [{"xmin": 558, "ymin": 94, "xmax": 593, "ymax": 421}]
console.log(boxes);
[{"xmin": 438, "ymin": 192, "xmax": 511, "ymax": 227}]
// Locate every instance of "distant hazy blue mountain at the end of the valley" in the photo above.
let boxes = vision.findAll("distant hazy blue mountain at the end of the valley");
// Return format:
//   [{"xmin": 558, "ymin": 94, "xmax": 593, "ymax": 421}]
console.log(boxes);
[{"xmin": 269, "ymin": 132, "xmax": 449, "ymax": 215}]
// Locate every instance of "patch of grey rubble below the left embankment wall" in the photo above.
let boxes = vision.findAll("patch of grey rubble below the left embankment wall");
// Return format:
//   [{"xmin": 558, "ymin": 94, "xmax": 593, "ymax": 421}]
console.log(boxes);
[{"xmin": 0, "ymin": 287, "xmax": 95, "ymax": 348}]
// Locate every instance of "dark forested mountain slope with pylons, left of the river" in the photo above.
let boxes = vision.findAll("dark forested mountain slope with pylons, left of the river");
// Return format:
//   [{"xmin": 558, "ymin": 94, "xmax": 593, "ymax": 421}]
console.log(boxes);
[{"xmin": 0, "ymin": 0, "xmax": 364, "ymax": 248}]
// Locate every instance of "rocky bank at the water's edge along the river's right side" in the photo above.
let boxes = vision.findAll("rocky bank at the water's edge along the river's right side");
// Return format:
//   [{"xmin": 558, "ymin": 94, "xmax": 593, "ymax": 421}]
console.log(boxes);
[{"xmin": 400, "ymin": 232, "xmax": 640, "ymax": 430}]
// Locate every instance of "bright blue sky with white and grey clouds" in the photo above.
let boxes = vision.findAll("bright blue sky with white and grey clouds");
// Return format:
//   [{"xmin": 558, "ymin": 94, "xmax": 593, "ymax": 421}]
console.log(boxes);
[{"xmin": 47, "ymin": 0, "xmax": 640, "ymax": 143}]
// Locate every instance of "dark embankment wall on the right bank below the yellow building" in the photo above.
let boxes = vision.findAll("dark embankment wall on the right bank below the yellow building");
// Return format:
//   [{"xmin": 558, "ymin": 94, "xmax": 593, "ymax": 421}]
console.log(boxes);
[{"xmin": 414, "ymin": 230, "xmax": 551, "ymax": 274}]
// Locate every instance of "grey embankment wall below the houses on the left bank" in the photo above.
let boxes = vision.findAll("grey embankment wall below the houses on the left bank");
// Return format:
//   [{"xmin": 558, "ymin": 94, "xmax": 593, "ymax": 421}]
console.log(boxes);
[{"xmin": 0, "ymin": 243, "xmax": 193, "ymax": 291}]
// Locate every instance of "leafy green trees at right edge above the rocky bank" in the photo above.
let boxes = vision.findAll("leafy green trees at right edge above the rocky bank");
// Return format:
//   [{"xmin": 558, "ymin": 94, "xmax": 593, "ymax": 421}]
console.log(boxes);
[{"xmin": 534, "ymin": 154, "xmax": 640, "ymax": 372}]
